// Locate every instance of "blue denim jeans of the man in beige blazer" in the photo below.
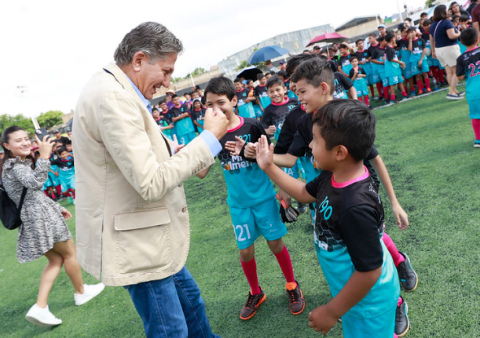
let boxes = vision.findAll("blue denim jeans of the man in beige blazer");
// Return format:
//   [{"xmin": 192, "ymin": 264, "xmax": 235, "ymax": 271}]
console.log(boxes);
[{"xmin": 125, "ymin": 266, "xmax": 218, "ymax": 338}]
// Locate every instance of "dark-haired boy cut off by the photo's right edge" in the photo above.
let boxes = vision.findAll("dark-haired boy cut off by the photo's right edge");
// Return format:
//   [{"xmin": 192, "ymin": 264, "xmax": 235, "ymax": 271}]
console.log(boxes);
[{"xmin": 457, "ymin": 27, "xmax": 480, "ymax": 148}]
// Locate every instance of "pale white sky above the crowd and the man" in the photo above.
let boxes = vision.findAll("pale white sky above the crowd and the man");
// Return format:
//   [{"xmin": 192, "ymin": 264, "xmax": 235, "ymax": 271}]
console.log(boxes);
[{"xmin": 0, "ymin": 0, "xmax": 425, "ymax": 117}]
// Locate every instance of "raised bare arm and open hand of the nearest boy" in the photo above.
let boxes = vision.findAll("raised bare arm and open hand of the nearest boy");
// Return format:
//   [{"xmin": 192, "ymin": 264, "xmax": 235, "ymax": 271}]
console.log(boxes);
[{"xmin": 257, "ymin": 135, "xmax": 315, "ymax": 203}]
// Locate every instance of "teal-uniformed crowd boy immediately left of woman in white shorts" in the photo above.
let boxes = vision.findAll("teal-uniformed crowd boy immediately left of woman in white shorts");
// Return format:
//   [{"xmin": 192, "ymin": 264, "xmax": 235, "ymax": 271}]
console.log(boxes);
[{"xmin": 407, "ymin": 27, "xmax": 432, "ymax": 94}]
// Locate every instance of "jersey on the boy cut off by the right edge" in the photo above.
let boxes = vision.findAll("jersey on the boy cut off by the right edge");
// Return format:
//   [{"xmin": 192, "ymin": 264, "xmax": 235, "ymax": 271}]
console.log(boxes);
[{"xmin": 456, "ymin": 47, "xmax": 480, "ymax": 101}]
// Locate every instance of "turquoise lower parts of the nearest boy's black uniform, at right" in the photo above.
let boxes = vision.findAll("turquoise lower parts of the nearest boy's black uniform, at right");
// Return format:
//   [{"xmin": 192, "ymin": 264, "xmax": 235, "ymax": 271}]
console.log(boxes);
[{"xmin": 314, "ymin": 239, "xmax": 400, "ymax": 320}]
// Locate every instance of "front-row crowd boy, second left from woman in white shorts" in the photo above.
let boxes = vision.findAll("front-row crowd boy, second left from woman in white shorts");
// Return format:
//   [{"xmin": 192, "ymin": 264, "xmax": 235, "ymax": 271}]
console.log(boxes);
[{"xmin": 384, "ymin": 31, "xmax": 407, "ymax": 103}]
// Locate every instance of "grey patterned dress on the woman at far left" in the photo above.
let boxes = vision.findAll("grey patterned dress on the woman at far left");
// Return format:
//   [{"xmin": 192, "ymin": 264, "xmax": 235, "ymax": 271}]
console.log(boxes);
[{"xmin": 2, "ymin": 157, "xmax": 72, "ymax": 263}]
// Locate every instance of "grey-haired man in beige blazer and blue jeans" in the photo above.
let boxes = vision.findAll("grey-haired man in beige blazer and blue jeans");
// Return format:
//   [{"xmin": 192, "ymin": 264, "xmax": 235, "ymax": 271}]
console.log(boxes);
[{"xmin": 72, "ymin": 22, "xmax": 228, "ymax": 338}]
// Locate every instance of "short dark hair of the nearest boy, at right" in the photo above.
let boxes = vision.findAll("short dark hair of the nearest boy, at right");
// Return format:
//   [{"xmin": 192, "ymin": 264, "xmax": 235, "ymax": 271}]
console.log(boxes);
[{"xmin": 313, "ymin": 99, "xmax": 377, "ymax": 161}]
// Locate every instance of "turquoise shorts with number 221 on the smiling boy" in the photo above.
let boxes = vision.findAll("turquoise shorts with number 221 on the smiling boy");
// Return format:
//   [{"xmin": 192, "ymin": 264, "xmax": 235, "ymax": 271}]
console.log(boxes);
[{"xmin": 230, "ymin": 197, "xmax": 287, "ymax": 250}]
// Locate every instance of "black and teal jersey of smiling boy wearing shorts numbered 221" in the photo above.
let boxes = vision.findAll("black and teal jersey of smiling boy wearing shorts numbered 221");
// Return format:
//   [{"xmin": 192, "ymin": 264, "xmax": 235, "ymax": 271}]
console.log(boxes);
[{"xmin": 218, "ymin": 116, "xmax": 276, "ymax": 208}]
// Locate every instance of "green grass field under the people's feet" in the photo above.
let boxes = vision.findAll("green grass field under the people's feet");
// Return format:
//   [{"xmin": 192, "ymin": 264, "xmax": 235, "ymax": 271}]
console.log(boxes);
[{"xmin": 0, "ymin": 86, "xmax": 480, "ymax": 338}]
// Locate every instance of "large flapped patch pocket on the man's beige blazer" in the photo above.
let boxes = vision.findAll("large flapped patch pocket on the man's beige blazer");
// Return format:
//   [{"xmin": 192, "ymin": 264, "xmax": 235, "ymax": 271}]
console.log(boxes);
[{"xmin": 114, "ymin": 208, "xmax": 173, "ymax": 274}]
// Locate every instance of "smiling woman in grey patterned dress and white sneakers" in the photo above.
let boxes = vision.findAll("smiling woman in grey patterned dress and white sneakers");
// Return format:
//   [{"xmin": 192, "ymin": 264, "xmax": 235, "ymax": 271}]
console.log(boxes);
[{"xmin": 0, "ymin": 126, "xmax": 105, "ymax": 326}]
